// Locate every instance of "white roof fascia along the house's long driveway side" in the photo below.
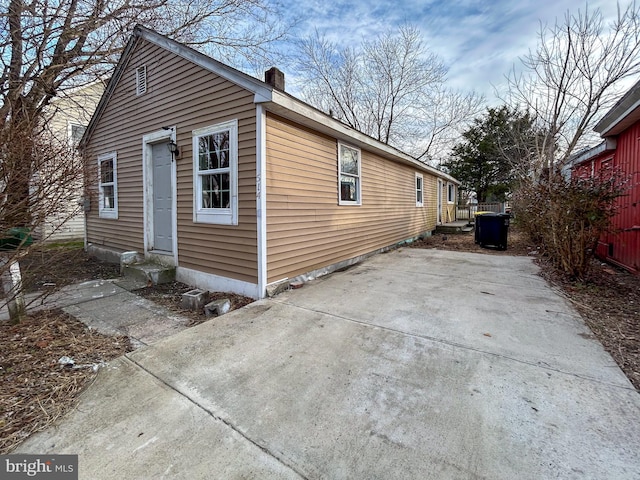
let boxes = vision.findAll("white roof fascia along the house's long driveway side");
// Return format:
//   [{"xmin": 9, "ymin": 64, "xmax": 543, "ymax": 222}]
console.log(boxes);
[{"xmin": 266, "ymin": 90, "xmax": 460, "ymax": 185}]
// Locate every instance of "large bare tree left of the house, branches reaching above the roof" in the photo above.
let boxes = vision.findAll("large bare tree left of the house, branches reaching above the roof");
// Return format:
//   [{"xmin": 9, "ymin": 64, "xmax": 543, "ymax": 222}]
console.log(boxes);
[{"xmin": 0, "ymin": 0, "xmax": 286, "ymax": 322}]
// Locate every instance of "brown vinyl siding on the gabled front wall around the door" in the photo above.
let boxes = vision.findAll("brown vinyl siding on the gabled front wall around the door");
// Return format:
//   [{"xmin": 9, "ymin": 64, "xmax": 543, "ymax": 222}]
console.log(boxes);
[{"xmin": 88, "ymin": 41, "xmax": 257, "ymax": 283}]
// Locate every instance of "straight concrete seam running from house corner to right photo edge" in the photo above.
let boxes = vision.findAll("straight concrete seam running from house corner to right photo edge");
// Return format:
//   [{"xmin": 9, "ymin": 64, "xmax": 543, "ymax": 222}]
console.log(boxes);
[{"xmin": 272, "ymin": 298, "xmax": 636, "ymax": 392}]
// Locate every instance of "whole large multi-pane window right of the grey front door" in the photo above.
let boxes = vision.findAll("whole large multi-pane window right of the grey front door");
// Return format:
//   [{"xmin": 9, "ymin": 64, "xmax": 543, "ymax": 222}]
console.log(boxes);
[{"xmin": 193, "ymin": 120, "xmax": 238, "ymax": 225}]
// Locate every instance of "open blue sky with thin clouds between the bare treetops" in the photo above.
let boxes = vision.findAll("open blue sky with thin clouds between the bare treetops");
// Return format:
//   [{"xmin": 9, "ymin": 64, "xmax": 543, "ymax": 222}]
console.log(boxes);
[{"xmin": 283, "ymin": 0, "xmax": 626, "ymax": 102}]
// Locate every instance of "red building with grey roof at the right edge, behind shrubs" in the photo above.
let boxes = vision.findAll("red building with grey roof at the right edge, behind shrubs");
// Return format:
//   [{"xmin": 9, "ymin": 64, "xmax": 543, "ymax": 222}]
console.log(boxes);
[{"xmin": 572, "ymin": 82, "xmax": 640, "ymax": 274}]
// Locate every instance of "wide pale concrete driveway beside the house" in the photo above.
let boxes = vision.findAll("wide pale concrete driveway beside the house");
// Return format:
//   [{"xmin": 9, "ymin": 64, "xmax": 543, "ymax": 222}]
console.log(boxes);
[{"xmin": 19, "ymin": 248, "xmax": 640, "ymax": 479}]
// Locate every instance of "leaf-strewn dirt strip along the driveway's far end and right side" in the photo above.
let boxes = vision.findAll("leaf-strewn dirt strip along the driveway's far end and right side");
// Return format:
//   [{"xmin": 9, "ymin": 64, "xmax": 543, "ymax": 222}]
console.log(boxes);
[{"xmin": 411, "ymin": 227, "xmax": 640, "ymax": 391}]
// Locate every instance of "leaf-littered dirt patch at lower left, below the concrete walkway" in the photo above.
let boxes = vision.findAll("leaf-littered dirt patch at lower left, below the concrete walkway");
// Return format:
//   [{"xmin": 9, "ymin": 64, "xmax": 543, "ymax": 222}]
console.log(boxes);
[{"xmin": 0, "ymin": 310, "xmax": 131, "ymax": 454}]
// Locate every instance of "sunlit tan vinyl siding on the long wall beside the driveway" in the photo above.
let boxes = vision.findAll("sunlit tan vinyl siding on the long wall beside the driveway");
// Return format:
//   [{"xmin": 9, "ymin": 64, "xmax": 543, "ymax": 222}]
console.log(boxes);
[{"xmin": 267, "ymin": 115, "xmax": 436, "ymax": 282}]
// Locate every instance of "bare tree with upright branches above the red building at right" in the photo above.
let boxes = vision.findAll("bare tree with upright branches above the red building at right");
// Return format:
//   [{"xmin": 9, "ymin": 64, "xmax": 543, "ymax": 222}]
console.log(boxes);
[{"xmin": 506, "ymin": 2, "xmax": 640, "ymax": 177}]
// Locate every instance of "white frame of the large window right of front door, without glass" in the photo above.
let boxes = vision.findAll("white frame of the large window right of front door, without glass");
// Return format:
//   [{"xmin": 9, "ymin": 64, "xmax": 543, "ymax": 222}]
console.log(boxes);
[{"xmin": 192, "ymin": 120, "xmax": 238, "ymax": 225}]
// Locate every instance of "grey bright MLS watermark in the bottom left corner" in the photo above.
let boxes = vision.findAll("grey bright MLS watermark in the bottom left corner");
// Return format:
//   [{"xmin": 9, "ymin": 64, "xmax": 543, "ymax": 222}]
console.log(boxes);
[{"xmin": 0, "ymin": 454, "xmax": 78, "ymax": 480}]
